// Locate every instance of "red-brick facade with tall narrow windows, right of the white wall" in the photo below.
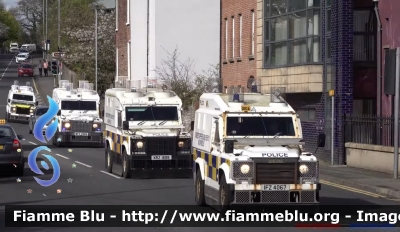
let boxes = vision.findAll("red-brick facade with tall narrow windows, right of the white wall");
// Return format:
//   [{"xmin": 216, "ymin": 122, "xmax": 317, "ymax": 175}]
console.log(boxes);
[{"xmin": 220, "ymin": 0, "xmax": 257, "ymax": 86}]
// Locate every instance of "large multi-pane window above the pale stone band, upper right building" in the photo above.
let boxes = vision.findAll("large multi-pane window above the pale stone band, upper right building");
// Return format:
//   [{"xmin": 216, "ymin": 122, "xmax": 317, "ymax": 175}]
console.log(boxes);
[{"xmin": 264, "ymin": 0, "xmax": 320, "ymax": 67}]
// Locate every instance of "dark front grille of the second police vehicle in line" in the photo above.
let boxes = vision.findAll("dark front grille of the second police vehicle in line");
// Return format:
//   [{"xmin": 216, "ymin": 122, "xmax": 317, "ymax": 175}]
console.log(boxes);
[{"xmin": 145, "ymin": 137, "xmax": 177, "ymax": 155}]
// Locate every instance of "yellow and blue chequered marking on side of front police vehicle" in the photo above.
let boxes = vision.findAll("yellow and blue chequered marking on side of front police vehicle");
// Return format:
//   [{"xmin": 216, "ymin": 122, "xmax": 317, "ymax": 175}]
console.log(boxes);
[{"xmin": 193, "ymin": 148, "xmax": 231, "ymax": 181}]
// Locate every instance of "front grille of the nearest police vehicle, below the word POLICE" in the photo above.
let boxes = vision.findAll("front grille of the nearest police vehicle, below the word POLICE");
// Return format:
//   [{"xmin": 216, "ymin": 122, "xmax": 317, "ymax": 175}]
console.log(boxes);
[{"xmin": 255, "ymin": 163, "xmax": 298, "ymax": 184}]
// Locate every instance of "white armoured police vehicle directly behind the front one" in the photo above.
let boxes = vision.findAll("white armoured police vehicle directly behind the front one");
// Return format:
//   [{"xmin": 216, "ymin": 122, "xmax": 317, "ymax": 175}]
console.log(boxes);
[{"xmin": 104, "ymin": 80, "xmax": 193, "ymax": 178}]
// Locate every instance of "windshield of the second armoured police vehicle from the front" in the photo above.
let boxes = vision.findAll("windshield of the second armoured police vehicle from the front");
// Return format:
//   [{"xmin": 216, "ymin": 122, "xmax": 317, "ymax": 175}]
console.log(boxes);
[{"xmin": 125, "ymin": 106, "xmax": 178, "ymax": 121}]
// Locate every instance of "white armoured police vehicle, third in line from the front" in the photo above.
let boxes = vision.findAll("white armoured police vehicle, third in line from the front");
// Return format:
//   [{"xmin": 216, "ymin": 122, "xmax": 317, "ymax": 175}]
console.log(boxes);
[{"xmin": 53, "ymin": 80, "xmax": 103, "ymax": 147}]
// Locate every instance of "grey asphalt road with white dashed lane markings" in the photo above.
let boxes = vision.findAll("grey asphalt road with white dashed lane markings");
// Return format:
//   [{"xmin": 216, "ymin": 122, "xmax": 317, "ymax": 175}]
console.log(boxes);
[{"xmin": 0, "ymin": 52, "xmax": 399, "ymax": 232}]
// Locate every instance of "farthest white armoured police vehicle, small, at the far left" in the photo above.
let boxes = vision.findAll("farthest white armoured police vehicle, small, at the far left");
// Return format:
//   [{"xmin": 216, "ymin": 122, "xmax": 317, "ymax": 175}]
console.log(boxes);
[{"xmin": 6, "ymin": 81, "xmax": 39, "ymax": 122}]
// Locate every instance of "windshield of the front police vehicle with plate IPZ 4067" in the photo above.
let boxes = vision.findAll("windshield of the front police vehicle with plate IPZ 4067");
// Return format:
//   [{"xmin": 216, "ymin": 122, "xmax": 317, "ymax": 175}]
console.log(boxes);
[{"xmin": 226, "ymin": 117, "xmax": 296, "ymax": 136}]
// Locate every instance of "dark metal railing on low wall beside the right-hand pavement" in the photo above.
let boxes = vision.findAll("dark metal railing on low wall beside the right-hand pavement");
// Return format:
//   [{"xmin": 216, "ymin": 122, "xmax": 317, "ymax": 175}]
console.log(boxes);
[{"xmin": 343, "ymin": 114, "xmax": 399, "ymax": 147}]
